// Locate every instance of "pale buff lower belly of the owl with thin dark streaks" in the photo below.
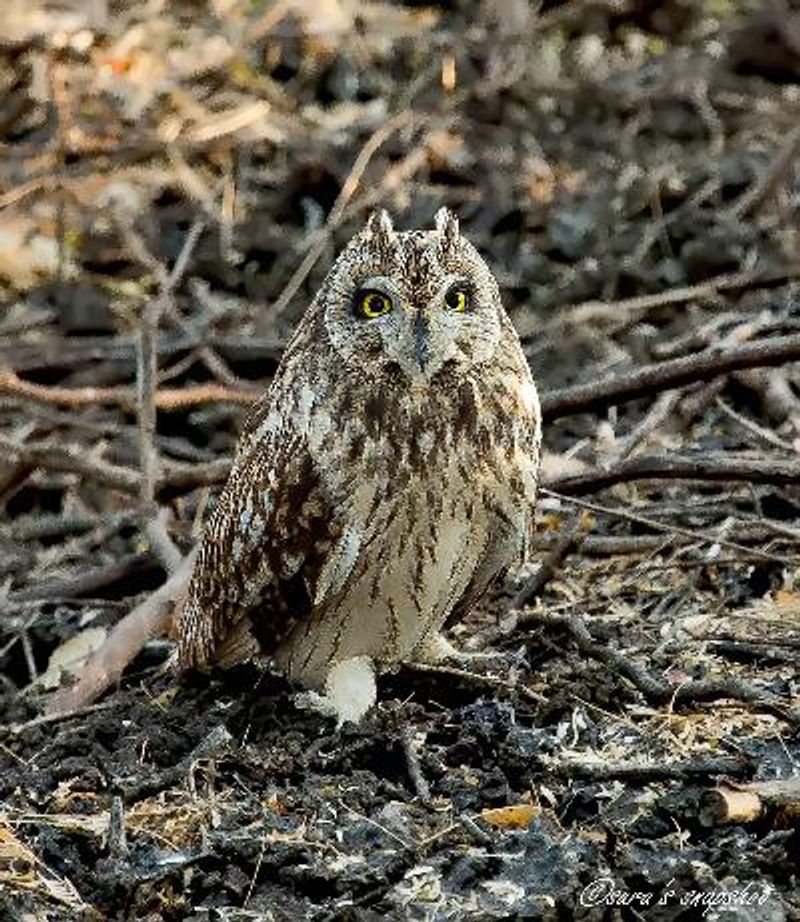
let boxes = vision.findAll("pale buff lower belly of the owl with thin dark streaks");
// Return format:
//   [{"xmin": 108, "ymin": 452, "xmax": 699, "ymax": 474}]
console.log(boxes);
[{"xmin": 275, "ymin": 470, "xmax": 529, "ymax": 686}]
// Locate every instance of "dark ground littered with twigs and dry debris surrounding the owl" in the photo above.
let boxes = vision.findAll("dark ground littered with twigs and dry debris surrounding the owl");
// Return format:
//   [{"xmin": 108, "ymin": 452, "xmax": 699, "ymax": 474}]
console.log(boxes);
[{"xmin": 0, "ymin": 0, "xmax": 800, "ymax": 922}]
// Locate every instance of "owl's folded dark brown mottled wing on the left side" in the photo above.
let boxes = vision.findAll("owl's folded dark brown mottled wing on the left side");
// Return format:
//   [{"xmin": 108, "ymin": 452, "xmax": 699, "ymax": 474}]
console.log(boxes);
[{"xmin": 178, "ymin": 406, "xmax": 334, "ymax": 668}]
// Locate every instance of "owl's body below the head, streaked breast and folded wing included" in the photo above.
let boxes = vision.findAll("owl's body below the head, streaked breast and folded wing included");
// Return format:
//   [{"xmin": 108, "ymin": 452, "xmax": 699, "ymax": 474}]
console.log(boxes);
[{"xmin": 178, "ymin": 330, "xmax": 540, "ymax": 675}]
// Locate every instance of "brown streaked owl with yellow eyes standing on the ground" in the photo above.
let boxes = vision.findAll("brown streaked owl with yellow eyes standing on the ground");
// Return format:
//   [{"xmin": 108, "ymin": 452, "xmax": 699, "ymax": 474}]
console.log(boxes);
[{"xmin": 178, "ymin": 209, "xmax": 540, "ymax": 716}]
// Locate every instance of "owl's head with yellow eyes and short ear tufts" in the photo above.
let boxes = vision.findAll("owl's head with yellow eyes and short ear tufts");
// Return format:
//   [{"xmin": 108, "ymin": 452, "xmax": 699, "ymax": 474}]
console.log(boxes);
[{"xmin": 317, "ymin": 208, "xmax": 503, "ymax": 386}]
